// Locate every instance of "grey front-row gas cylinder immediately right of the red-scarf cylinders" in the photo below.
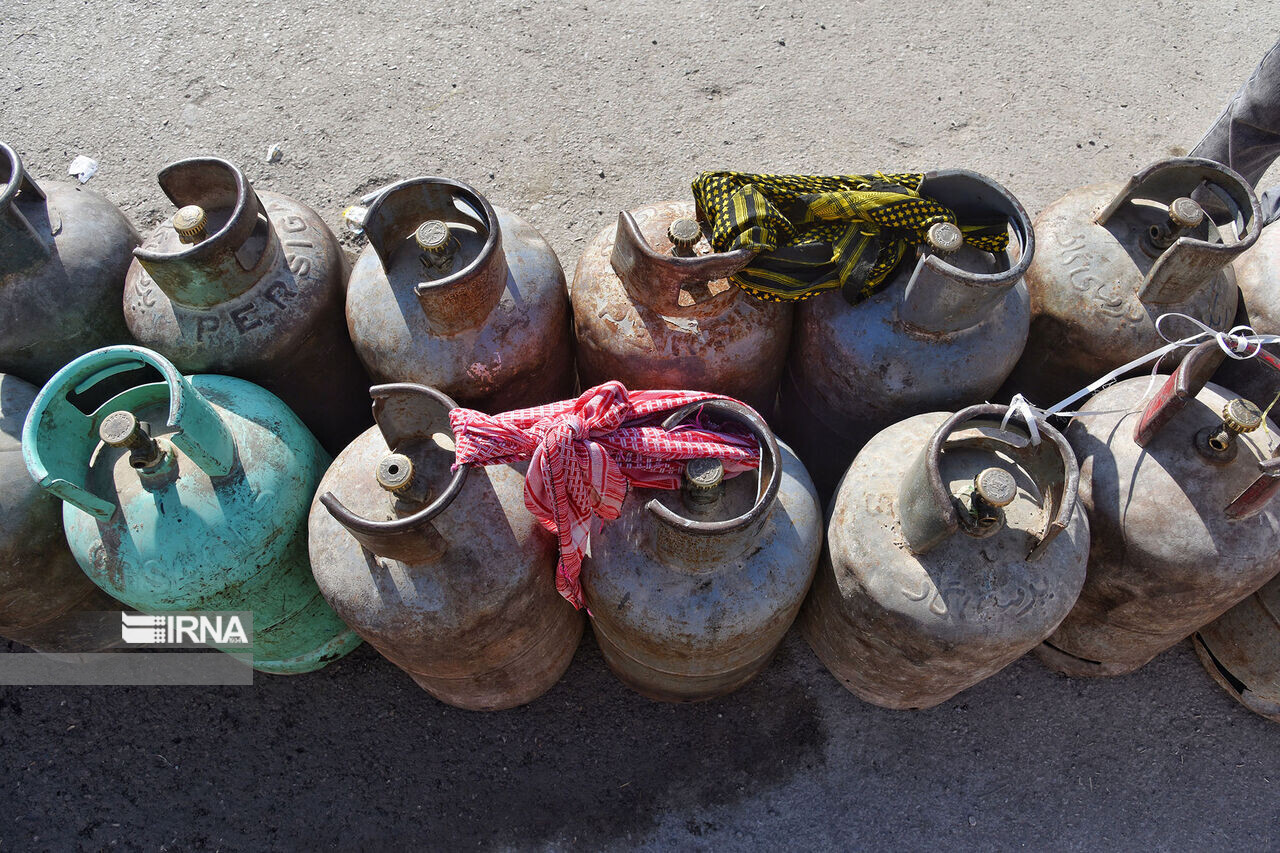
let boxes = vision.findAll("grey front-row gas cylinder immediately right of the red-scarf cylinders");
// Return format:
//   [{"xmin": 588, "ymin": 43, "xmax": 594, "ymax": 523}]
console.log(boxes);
[{"xmin": 800, "ymin": 403, "xmax": 1089, "ymax": 710}]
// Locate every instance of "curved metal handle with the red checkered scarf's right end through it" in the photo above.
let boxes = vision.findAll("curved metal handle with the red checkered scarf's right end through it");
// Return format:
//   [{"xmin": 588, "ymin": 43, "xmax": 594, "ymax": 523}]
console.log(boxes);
[{"xmin": 645, "ymin": 400, "xmax": 782, "ymax": 537}]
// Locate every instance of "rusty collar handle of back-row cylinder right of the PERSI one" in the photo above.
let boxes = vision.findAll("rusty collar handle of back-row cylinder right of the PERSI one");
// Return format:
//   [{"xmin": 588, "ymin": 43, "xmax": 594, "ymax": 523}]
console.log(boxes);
[{"xmin": 364, "ymin": 175, "xmax": 507, "ymax": 333}]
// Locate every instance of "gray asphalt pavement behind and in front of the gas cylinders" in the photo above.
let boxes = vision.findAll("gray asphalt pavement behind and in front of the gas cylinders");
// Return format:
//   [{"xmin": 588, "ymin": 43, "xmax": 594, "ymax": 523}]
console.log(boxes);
[{"xmin": 0, "ymin": 0, "xmax": 1280, "ymax": 850}]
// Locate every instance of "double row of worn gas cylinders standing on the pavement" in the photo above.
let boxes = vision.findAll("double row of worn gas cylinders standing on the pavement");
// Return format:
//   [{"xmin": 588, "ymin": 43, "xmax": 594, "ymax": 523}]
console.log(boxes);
[{"xmin": 0, "ymin": 140, "xmax": 1280, "ymax": 715}]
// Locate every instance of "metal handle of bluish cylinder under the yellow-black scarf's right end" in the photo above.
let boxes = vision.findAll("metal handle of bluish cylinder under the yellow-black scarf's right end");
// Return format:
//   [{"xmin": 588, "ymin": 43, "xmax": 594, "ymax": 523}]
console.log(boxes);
[{"xmin": 899, "ymin": 169, "xmax": 1036, "ymax": 333}]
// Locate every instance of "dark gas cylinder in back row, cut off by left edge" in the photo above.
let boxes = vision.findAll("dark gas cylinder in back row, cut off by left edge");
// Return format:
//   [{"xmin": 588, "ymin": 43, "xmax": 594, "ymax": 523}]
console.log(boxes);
[{"xmin": 0, "ymin": 142, "xmax": 138, "ymax": 384}]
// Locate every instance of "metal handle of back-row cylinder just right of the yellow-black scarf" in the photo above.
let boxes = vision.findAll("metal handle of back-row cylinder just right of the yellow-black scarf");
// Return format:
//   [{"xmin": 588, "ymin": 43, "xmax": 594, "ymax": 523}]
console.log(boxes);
[{"xmin": 1094, "ymin": 158, "xmax": 1262, "ymax": 304}]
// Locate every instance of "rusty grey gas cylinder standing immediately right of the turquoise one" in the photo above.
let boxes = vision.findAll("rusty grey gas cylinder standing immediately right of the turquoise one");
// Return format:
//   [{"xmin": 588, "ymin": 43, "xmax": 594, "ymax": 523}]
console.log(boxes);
[{"xmin": 310, "ymin": 383, "xmax": 582, "ymax": 711}]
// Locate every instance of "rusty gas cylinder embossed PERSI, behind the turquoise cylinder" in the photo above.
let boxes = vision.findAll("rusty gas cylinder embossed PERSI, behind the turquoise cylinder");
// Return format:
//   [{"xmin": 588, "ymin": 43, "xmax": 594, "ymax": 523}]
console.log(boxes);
[{"xmin": 124, "ymin": 158, "xmax": 369, "ymax": 451}]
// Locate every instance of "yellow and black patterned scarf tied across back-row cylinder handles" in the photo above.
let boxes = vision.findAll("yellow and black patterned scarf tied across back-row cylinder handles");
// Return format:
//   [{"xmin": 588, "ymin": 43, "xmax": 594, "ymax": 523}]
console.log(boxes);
[{"xmin": 694, "ymin": 172, "xmax": 1009, "ymax": 304}]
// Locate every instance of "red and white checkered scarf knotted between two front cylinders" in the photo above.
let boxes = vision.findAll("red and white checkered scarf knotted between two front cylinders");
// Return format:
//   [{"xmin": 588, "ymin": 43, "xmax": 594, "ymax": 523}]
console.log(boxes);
[{"xmin": 449, "ymin": 382, "xmax": 760, "ymax": 607}]
